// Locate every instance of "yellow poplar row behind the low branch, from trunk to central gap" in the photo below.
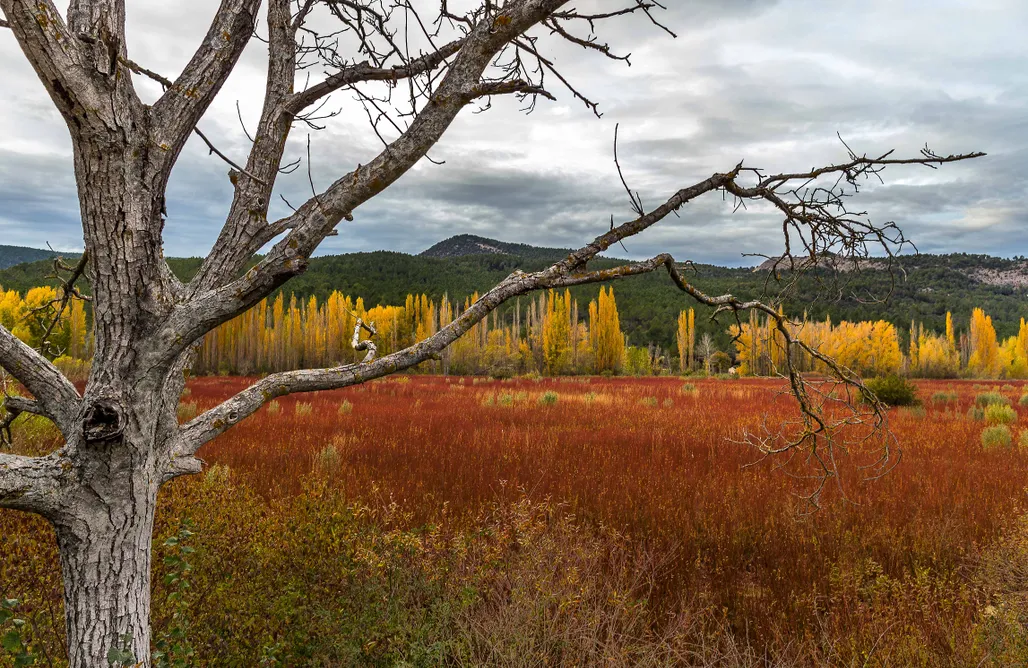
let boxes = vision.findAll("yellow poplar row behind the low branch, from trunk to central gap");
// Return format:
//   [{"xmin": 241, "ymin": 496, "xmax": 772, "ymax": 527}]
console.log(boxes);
[{"xmin": 186, "ymin": 289, "xmax": 630, "ymax": 376}]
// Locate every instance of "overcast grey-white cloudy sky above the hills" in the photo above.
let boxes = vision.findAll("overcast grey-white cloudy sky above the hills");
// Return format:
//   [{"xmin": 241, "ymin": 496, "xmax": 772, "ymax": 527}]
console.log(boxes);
[{"xmin": 0, "ymin": 0, "xmax": 1028, "ymax": 265}]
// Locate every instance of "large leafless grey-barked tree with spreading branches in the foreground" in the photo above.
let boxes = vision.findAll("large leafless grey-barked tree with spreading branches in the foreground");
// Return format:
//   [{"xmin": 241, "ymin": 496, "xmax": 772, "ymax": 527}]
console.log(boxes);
[{"xmin": 0, "ymin": 0, "xmax": 981, "ymax": 668}]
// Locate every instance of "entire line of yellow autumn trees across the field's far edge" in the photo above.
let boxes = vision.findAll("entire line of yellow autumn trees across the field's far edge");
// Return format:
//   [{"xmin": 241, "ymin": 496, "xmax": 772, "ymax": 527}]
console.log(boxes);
[{"xmin": 8, "ymin": 277, "xmax": 1028, "ymax": 378}]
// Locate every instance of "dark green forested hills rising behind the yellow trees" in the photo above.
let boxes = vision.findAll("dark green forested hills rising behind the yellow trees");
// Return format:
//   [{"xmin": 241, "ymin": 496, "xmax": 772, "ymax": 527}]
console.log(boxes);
[{"xmin": 0, "ymin": 235, "xmax": 1028, "ymax": 347}]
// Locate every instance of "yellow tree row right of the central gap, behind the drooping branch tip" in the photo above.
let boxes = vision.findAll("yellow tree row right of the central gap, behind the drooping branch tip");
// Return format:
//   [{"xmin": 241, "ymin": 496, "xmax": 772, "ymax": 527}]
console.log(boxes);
[{"xmin": 715, "ymin": 308, "xmax": 1028, "ymax": 378}]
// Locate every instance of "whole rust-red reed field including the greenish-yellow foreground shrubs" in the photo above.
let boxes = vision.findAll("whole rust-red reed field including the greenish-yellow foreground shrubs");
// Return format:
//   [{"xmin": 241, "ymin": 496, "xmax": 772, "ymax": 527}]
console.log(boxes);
[{"xmin": 0, "ymin": 376, "xmax": 1028, "ymax": 667}]
